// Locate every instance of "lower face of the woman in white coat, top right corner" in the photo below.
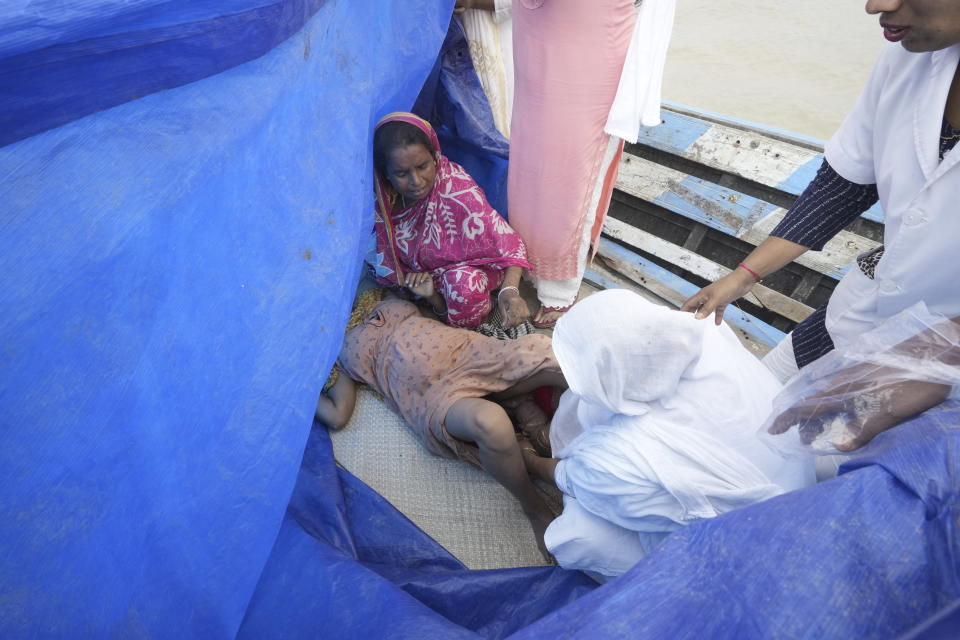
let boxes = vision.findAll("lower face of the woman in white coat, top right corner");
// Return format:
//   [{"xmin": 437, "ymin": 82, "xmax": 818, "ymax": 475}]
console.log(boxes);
[{"xmin": 867, "ymin": 0, "xmax": 960, "ymax": 53}]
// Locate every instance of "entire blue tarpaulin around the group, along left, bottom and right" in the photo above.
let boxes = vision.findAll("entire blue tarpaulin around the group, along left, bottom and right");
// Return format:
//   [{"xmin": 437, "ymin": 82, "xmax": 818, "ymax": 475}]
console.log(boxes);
[{"xmin": 0, "ymin": 0, "xmax": 960, "ymax": 639}]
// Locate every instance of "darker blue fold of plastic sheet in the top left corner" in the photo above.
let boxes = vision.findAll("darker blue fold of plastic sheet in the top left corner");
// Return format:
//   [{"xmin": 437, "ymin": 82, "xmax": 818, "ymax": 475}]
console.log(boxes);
[{"xmin": 0, "ymin": 0, "xmax": 338, "ymax": 146}]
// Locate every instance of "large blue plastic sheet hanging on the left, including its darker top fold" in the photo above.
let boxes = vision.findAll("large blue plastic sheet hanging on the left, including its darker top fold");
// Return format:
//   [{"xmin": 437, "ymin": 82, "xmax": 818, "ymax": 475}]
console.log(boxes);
[{"xmin": 0, "ymin": 0, "xmax": 464, "ymax": 638}]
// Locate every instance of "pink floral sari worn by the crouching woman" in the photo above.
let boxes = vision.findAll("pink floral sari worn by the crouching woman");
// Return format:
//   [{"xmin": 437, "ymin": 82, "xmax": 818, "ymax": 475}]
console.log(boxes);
[{"xmin": 367, "ymin": 113, "xmax": 530, "ymax": 328}]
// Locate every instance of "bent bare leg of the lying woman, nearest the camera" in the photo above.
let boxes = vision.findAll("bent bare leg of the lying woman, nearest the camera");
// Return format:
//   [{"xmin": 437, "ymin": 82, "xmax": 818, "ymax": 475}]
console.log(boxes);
[{"xmin": 445, "ymin": 398, "xmax": 553, "ymax": 557}]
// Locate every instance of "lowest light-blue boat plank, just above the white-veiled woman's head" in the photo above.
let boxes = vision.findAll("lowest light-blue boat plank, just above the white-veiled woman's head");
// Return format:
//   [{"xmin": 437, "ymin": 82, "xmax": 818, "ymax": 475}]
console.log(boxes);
[{"xmin": 587, "ymin": 238, "xmax": 785, "ymax": 356}]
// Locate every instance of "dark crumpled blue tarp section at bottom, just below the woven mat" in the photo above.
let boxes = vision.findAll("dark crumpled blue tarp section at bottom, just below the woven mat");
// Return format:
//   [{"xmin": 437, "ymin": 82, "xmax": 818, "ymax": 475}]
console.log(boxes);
[{"xmin": 240, "ymin": 427, "xmax": 596, "ymax": 638}]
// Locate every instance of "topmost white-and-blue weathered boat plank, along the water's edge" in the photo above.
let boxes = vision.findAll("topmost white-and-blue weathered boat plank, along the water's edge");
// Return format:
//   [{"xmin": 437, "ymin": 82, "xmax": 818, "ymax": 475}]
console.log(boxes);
[{"xmin": 638, "ymin": 109, "xmax": 883, "ymax": 222}]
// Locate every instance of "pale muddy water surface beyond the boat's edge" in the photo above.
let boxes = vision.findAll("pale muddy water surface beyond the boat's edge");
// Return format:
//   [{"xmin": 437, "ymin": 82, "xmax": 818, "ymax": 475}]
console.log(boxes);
[{"xmin": 663, "ymin": 0, "xmax": 886, "ymax": 139}]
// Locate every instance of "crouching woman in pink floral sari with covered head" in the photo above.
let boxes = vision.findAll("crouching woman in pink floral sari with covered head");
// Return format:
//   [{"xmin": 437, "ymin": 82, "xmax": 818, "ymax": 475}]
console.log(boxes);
[{"xmin": 368, "ymin": 113, "xmax": 530, "ymax": 329}]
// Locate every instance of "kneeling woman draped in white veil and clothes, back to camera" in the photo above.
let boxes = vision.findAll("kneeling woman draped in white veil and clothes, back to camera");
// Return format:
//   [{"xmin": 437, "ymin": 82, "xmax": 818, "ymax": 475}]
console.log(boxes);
[{"xmin": 524, "ymin": 290, "xmax": 813, "ymax": 577}]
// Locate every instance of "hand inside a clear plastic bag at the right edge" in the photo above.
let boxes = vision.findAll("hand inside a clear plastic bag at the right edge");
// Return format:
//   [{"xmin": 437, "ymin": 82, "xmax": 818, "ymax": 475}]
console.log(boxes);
[{"xmin": 767, "ymin": 365, "xmax": 951, "ymax": 452}]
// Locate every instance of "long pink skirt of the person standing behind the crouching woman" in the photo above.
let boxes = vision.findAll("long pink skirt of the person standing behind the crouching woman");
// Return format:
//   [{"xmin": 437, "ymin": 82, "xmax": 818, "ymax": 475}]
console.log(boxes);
[{"xmin": 508, "ymin": 0, "xmax": 636, "ymax": 303}]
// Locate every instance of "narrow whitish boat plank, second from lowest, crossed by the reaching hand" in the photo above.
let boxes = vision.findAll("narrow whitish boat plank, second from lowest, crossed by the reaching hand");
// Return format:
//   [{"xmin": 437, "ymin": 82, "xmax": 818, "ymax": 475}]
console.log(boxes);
[{"xmin": 603, "ymin": 218, "xmax": 813, "ymax": 322}]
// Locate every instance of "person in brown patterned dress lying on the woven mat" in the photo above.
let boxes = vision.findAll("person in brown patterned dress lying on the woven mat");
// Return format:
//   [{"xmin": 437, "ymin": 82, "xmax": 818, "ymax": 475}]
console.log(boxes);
[{"xmin": 316, "ymin": 289, "xmax": 566, "ymax": 550}]
